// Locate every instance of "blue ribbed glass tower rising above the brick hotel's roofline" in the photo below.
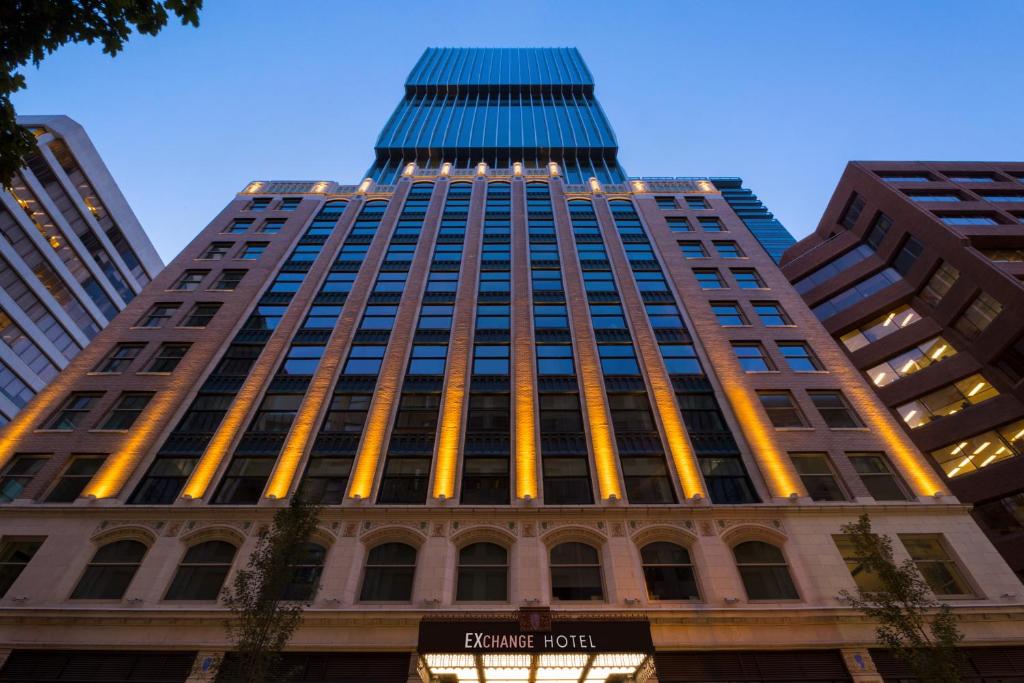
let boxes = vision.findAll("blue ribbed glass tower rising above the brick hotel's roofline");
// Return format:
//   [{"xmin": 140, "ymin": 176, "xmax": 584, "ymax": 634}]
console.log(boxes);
[{"xmin": 368, "ymin": 48, "xmax": 626, "ymax": 182}]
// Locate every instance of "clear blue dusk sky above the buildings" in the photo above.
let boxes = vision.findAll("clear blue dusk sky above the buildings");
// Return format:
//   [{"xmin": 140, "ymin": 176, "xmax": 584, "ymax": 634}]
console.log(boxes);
[{"xmin": 14, "ymin": 0, "xmax": 1024, "ymax": 260}]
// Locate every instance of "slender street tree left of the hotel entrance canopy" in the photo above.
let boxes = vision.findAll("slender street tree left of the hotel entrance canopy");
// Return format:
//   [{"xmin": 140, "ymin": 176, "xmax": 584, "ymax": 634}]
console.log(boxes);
[{"xmin": 222, "ymin": 496, "xmax": 319, "ymax": 683}]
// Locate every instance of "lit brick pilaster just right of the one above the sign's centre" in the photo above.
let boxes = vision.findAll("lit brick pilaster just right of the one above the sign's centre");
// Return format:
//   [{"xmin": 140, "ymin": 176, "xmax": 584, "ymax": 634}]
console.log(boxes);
[{"xmin": 550, "ymin": 189, "xmax": 623, "ymax": 501}]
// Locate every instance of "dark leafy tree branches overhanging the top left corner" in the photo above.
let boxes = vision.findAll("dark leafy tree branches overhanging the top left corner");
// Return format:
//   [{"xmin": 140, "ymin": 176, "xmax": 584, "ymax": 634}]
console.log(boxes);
[{"xmin": 0, "ymin": 0, "xmax": 203, "ymax": 186}]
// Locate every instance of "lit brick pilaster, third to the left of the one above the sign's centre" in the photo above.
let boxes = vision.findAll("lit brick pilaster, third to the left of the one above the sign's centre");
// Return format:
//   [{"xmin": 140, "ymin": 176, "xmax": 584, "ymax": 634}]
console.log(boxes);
[{"xmin": 264, "ymin": 189, "xmax": 408, "ymax": 498}]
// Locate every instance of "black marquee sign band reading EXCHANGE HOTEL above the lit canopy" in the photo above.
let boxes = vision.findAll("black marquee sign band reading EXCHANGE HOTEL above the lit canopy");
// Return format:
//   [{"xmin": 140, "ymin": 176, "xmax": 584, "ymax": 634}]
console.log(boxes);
[{"xmin": 417, "ymin": 618, "xmax": 654, "ymax": 654}]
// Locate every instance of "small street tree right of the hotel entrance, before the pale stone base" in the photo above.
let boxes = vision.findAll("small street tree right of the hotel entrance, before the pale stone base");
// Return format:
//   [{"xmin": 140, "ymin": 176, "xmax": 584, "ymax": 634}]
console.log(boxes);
[{"xmin": 839, "ymin": 514, "xmax": 964, "ymax": 683}]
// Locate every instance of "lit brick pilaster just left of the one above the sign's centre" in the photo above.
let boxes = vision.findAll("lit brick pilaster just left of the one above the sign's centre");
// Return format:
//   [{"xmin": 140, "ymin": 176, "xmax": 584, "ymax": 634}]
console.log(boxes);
[{"xmin": 431, "ymin": 182, "xmax": 487, "ymax": 500}]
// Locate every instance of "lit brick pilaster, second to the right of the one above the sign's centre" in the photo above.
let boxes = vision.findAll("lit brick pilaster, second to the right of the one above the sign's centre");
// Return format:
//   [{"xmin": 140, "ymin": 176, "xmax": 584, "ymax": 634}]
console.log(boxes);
[{"xmin": 594, "ymin": 198, "xmax": 708, "ymax": 499}]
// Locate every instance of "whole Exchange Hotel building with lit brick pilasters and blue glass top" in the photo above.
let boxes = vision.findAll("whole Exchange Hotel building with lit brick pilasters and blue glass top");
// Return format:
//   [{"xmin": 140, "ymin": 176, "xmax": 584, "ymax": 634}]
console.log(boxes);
[{"xmin": 0, "ymin": 49, "xmax": 1024, "ymax": 683}]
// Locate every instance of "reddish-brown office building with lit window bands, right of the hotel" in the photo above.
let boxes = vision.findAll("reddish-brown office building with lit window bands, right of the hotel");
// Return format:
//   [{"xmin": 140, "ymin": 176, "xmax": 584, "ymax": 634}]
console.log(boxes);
[{"xmin": 782, "ymin": 162, "xmax": 1024, "ymax": 577}]
